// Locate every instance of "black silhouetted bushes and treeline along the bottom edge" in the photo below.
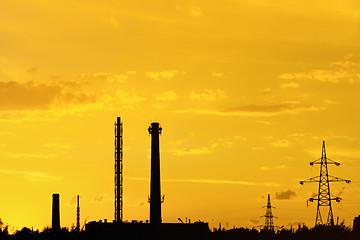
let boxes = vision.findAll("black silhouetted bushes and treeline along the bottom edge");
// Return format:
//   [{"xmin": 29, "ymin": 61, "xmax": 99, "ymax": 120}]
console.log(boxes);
[{"xmin": 0, "ymin": 224, "xmax": 360, "ymax": 240}]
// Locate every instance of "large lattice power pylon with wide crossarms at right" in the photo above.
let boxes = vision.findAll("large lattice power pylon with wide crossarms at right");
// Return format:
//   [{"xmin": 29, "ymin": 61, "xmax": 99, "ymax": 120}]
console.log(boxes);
[{"xmin": 300, "ymin": 141, "xmax": 350, "ymax": 226}]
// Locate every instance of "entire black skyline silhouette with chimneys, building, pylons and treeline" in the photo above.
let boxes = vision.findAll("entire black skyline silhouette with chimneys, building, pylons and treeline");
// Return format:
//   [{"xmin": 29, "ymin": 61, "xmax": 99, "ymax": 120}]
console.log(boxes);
[{"xmin": 0, "ymin": 117, "xmax": 360, "ymax": 240}]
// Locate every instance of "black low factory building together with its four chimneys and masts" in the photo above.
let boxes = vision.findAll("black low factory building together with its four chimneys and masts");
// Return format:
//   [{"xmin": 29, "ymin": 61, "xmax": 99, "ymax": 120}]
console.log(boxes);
[{"xmin": 52, "ymin": 117, "xmax": 210, "ymax": 239}]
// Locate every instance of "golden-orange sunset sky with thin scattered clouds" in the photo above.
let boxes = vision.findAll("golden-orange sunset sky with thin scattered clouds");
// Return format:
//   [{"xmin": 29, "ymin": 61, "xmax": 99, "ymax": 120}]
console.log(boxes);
[{"xmin": 0, "ymin": 0, "xmax": 360, "ymax": 232}]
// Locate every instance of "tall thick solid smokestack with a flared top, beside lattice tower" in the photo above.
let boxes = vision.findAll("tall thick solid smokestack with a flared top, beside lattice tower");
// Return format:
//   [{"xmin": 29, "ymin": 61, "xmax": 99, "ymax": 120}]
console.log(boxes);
[{"xmin": 148, "ymin": 122, "xmax": 162, "ymax": 223}]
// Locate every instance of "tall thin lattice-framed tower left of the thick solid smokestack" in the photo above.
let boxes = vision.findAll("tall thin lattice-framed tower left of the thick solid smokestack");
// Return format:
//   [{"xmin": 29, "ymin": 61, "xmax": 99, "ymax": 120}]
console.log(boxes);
[{"xmin": 115, "ymin": 117, "xmax": 123, "ymax": 222}]
